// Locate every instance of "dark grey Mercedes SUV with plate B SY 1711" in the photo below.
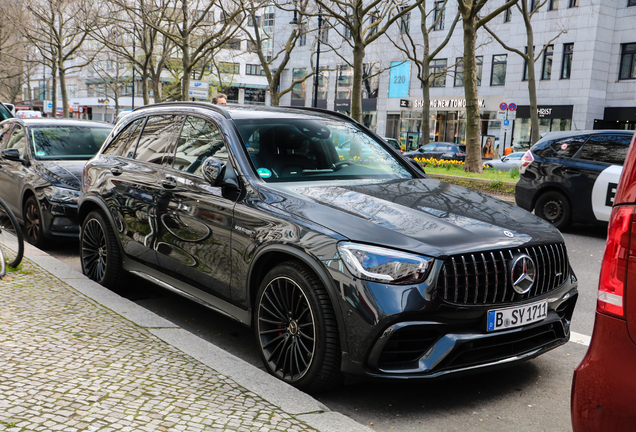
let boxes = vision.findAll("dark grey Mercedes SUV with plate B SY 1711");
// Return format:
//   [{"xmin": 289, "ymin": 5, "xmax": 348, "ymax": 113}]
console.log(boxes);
[{"xmin": 79, "ymin": 102, "xmax": 578, "ymax": 391}]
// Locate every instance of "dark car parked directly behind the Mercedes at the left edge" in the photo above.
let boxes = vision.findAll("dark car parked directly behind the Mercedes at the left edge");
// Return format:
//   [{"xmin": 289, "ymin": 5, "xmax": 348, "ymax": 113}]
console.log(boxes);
[{"xmin": 0, "ymin": 118, "xmax": 112, "ymax": 247}]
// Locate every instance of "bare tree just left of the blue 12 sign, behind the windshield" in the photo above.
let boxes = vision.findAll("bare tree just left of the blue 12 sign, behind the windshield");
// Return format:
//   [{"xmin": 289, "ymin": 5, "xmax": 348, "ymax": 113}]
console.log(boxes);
[{"xmin": 316, "ymin": 0, "xmax": 425, "ymax": 122}]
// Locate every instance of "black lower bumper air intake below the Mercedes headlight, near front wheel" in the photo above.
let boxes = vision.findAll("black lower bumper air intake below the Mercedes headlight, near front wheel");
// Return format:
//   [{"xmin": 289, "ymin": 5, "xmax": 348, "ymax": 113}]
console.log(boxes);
[{"xmin": 378, "ymin": 326, "xmax": 440, "ymax": 369}]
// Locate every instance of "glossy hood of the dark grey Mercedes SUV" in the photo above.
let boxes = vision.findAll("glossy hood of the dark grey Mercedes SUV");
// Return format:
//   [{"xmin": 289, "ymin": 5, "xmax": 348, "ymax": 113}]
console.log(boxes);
[{"xmin": 265, "ymin": 179, "xmax": 563, "ymax": 256}]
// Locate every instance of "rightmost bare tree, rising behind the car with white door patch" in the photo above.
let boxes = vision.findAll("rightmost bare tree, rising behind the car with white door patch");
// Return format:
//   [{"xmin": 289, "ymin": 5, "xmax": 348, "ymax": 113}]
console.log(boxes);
[{"xmin": 484, "ymin": 0, "xmax": 567, "ymax": 145}]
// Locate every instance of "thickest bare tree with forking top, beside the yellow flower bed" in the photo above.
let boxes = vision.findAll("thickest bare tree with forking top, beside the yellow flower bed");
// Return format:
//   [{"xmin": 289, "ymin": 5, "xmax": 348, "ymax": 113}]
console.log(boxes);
[{"xmin": 457, "ymin": 0, "xmax": 519, "ymax": 172}]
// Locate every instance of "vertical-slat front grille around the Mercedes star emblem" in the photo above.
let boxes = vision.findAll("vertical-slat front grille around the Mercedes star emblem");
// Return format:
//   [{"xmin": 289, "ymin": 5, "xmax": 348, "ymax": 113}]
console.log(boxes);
[{"xmin": 437, "ymin": 243, "xmax": 569, "ymax": 305}]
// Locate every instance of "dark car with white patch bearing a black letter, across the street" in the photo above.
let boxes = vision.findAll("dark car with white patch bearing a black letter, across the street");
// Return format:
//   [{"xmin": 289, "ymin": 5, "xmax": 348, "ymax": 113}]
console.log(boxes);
[{"xmin": 515, "ymin": 130, "xmax": 634, "ymax": 229}]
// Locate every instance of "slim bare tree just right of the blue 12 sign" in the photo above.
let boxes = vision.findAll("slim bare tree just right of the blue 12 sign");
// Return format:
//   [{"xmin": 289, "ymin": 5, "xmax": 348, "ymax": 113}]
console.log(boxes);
[{"xmin": 389, "ymin": 0, "xmax": 459, "ymax": 145}]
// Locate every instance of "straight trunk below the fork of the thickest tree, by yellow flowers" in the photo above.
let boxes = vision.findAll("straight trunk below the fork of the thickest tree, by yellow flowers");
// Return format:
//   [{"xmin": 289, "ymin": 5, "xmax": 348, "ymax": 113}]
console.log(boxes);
[{"xmin": 463, "ymin": 17, "xmax": 483, "ymax": 173}]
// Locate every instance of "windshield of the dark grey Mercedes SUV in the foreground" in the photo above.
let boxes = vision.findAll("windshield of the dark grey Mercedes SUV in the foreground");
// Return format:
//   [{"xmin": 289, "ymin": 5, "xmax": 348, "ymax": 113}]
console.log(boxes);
[{"xmin": 235, "ymin": 119, "xmax": 413, "ymax": 182}]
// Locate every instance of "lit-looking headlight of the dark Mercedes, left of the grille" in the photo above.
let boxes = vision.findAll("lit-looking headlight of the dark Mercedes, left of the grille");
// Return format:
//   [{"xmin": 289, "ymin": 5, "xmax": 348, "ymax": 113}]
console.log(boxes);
[{"xmin": 338, "ymin": 243, "xmax": 433, "ymax": 285}]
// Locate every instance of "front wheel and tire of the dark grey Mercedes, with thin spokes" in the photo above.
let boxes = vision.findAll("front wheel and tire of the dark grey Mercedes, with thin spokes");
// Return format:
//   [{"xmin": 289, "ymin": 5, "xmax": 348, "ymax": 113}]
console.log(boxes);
[{"xmin": 254, "ymin": 261, "xmax": 343, "ymax": 392}]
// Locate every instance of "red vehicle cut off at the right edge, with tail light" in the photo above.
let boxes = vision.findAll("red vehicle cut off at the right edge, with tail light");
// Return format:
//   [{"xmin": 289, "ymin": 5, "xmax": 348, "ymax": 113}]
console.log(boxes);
[{"xmin": 571, "ymin": 131, "xmax": 636, "ymax": 432}]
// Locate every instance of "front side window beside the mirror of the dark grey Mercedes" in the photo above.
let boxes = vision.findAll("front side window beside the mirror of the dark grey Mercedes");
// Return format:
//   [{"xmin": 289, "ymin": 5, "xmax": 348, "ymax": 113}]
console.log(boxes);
[{"xmin": 174, "ymin": 117, "xmax": 227, "ymax": 176}]
